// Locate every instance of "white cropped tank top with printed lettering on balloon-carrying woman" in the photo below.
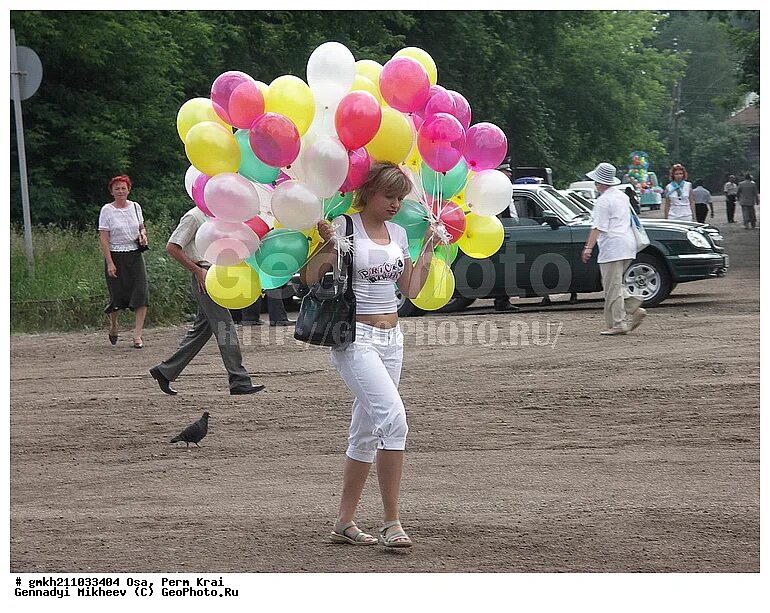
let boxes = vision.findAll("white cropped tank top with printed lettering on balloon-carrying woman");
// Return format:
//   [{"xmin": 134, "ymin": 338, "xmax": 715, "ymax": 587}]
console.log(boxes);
[{"xmin": 333, "ymin": 213, "xmax": 412, "ymax": 315}]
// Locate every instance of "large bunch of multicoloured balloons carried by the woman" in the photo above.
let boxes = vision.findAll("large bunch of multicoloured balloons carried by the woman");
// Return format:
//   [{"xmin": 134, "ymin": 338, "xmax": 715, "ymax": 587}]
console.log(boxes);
[{"xmin": 177, "ymin": 42, "xmax": 512, "ymax": 310}]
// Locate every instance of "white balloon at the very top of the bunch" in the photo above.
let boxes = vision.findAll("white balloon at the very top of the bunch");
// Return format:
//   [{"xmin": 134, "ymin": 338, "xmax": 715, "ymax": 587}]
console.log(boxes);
[{"xmin": 307, "ymin": 42, "xmax": 356, "ymax": 107}]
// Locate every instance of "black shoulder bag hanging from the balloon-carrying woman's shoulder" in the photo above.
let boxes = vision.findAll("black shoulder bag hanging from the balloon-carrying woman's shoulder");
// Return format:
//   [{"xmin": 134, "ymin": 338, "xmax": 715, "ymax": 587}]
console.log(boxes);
[{"xmin": 294, "ymin": 215, "xmax": 356, "ymax": 349}]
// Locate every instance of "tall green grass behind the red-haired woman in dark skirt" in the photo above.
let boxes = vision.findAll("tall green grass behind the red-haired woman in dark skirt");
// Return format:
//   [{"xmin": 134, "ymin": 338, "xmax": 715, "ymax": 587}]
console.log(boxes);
[{"xmin": 10, "ymin": 219, "xmax": 194, "ymax": 333}]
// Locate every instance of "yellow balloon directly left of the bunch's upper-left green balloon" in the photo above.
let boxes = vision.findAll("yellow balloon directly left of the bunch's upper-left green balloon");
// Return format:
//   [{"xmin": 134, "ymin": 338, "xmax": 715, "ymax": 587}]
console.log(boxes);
[{"xmin": 184, "ymin": 121, "xmax": 241, "ymax": 176}]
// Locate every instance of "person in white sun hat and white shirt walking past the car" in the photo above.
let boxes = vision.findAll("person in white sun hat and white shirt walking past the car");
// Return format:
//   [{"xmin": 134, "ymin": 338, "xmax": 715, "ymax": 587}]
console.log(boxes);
[{"xmin": 582, "ymin": 162, "xmax": 647, "ymax": 336}]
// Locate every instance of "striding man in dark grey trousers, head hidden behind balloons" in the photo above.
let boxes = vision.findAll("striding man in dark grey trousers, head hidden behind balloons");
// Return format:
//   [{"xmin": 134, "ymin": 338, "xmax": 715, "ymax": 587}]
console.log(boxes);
[{"xmin": 150, "ymin": 206, "xmax": 265, "ymax": 396}]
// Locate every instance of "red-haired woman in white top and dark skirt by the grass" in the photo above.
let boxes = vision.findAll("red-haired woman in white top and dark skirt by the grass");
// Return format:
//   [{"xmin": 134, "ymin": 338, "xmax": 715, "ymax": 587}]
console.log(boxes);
[{"xmin": 99, "ymin": 175, "xmax": 149, "ymax": 349}]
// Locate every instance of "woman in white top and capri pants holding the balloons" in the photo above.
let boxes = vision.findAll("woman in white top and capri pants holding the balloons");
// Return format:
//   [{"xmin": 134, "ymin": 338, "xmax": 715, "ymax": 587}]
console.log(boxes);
[{"xmin": 301, "ymin": 163, "xmax": 436, "ymax": 547}]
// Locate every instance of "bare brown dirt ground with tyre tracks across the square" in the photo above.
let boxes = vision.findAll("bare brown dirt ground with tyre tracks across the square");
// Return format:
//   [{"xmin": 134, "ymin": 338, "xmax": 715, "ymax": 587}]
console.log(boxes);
[{"xmin": 10, "ymin": 198, "xmax": 759, "ymax": 572}]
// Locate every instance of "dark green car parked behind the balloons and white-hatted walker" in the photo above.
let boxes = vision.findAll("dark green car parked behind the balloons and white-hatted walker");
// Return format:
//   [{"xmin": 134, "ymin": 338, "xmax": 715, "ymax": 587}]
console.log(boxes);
[{"xmin": 399, "ymin": 185, "xmax": 729, "ymax": 316}]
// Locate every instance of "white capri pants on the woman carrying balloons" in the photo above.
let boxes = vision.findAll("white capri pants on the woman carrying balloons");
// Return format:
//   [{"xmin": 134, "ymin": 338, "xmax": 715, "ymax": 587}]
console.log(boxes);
[{"xmin": 331, "ymin": 322, "xmax": 409, "ymax": 464}]
